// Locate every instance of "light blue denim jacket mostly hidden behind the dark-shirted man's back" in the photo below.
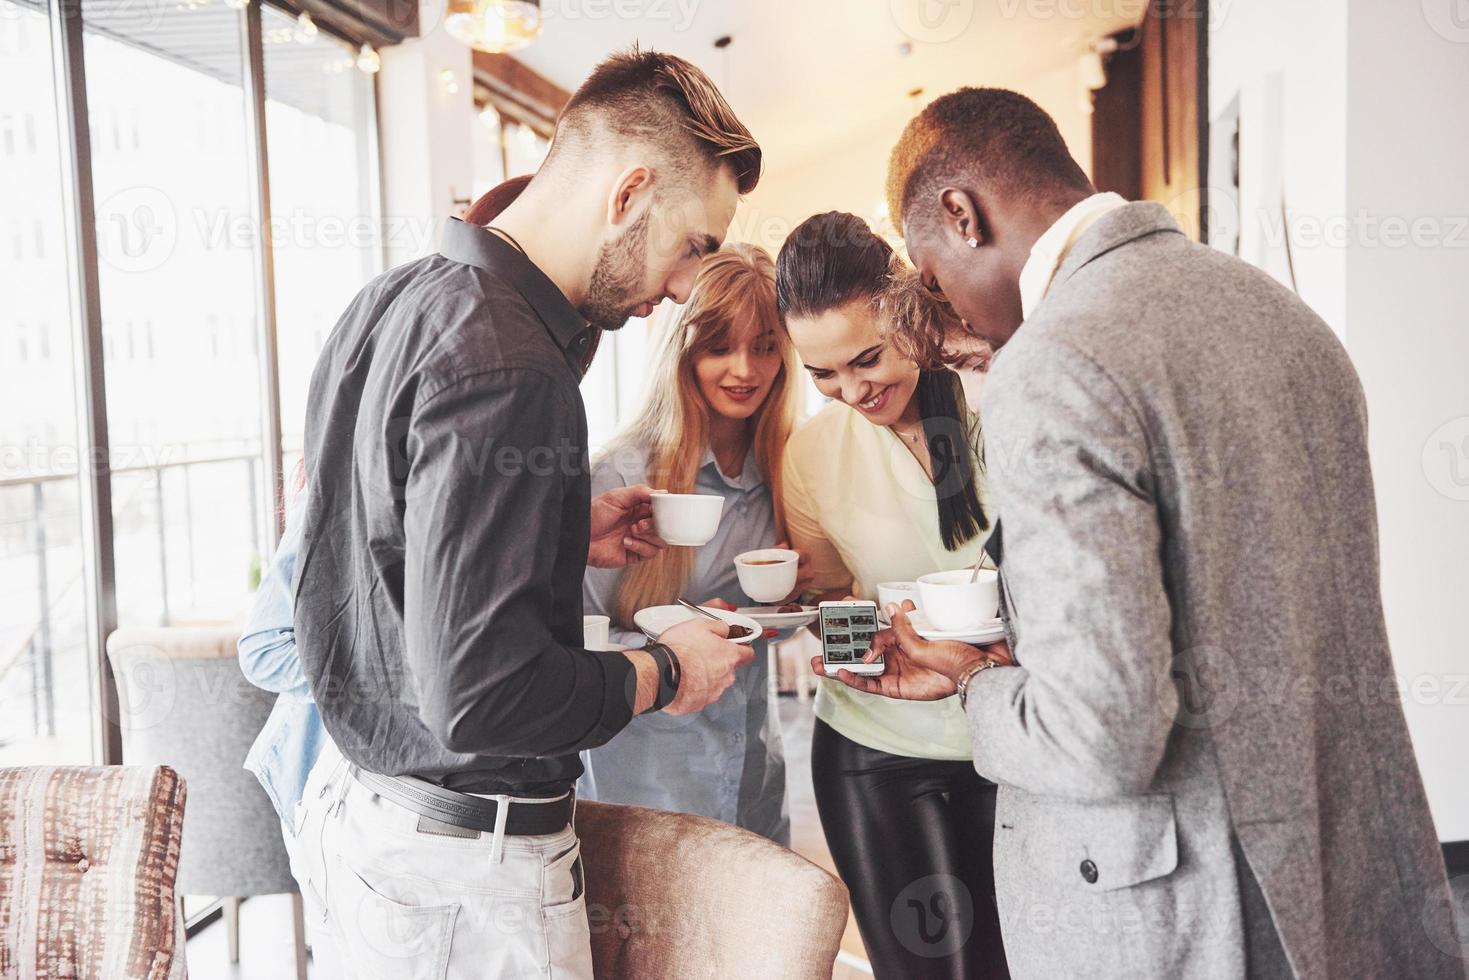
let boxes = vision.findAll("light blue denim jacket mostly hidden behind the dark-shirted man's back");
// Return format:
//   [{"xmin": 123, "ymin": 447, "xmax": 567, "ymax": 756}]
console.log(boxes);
[{"xmin": 238, "ymin": 505, "xmax": 328, "ymax": 832}]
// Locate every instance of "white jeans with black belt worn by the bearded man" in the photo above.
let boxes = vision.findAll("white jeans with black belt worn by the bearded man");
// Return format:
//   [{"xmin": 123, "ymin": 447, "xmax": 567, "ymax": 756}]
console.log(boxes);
[{"xmin": 292, "ymin": 748, "xmax": 592, "ymax": 980}]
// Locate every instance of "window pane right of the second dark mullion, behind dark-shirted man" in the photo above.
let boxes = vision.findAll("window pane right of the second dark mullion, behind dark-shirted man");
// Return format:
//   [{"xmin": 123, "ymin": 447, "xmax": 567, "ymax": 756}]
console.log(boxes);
[{"xmin": 261, "ymin": 7, "xmax": 383, "ymax": 473}]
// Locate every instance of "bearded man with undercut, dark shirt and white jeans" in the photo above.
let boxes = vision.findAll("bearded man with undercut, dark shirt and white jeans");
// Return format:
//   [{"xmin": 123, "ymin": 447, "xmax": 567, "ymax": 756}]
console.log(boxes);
[{"xmin": 294, "ymin": 50, "xmax": 761, "ymax": 980}]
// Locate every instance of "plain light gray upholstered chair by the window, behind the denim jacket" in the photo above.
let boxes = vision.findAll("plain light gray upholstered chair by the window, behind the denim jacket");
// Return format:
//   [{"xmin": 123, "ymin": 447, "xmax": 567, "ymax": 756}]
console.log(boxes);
[{"xmin": 107, "ymin": 627, "xmax": 295, "ymax": 896}]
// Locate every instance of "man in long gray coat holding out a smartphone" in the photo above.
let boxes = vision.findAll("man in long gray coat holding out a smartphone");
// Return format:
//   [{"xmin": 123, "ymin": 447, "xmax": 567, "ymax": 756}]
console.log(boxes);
[{"xmin": 843, "ymin": 90, "xmax": 1465, "ymax": 980}]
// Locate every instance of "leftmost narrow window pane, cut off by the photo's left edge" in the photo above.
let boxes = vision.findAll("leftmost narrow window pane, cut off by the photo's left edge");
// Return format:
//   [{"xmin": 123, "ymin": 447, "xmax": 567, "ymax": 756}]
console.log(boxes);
[{"xmin": 0, "ymin": 0, "xmax": 95, "ymax": 765}]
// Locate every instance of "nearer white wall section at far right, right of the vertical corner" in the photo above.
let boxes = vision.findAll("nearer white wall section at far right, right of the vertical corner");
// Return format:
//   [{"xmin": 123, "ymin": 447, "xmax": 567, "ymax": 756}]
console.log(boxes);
[{"xmin": 1346, "ymin": 0, "xmax": 1469, "ymax": 840}]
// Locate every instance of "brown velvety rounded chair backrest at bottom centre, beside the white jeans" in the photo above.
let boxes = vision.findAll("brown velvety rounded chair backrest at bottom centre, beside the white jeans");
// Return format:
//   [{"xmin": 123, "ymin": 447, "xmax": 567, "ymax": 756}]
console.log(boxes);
[{"xmin": 576, "ymin": 802, "xmax": 848, "ymax": 980}]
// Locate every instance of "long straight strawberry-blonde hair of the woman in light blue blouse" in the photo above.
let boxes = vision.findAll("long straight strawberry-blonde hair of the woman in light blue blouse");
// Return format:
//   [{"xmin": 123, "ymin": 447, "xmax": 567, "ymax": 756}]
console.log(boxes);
[{"xmin": 607, "ymin": 244, "xmax": 799, "ymax": 629}]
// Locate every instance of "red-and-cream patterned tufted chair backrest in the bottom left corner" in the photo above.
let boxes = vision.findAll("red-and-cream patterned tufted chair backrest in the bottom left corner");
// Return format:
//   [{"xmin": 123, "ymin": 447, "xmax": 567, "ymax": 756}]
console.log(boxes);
[{"xmin": 0, "ymin": 765, "xmax": 187, "ymax": 980}]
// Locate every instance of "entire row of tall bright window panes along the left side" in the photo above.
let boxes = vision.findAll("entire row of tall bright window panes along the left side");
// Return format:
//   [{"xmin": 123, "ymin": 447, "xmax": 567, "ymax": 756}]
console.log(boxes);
[{"xmin": 0, "ymin": 0, "xmax": 382, "ymax": 765}]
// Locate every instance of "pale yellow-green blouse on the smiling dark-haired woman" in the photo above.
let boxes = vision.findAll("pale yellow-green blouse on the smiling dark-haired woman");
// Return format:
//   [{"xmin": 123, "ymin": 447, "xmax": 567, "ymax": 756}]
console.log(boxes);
[{"xmin": 783, "ymin": 403, "xmax": 989, "ymax": 760}]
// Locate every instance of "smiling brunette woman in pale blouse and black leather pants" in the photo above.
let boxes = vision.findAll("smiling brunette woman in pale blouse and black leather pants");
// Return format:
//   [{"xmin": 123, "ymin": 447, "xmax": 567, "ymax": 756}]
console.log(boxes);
[{"xmin": 779, "ymin": 213, "xmax": 1008, "ymax": 980}]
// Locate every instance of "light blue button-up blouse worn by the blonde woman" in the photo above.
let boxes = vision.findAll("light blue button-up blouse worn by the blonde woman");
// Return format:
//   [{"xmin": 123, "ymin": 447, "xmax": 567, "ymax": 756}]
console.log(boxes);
[{"xmin": 577, "ymin": 445, "xmax": 790, "ymax": 846}]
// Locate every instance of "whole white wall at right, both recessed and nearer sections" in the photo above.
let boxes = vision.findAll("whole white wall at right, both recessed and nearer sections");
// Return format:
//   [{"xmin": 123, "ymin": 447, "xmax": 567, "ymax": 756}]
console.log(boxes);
[{"xmin": 1209, "ymin": 0, "xmax": 1469, "ymax": 840}]
